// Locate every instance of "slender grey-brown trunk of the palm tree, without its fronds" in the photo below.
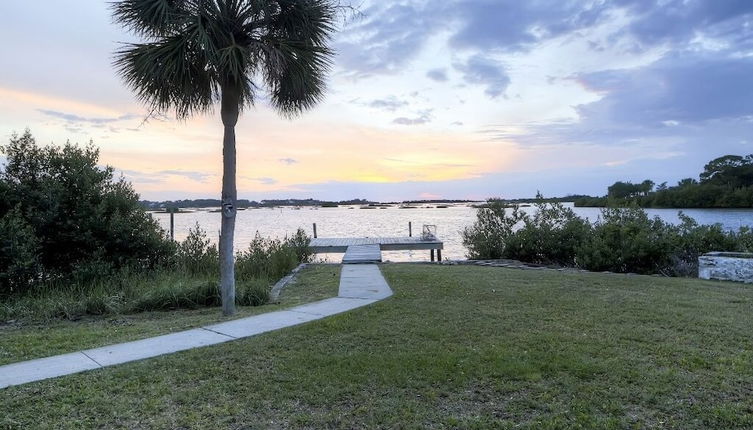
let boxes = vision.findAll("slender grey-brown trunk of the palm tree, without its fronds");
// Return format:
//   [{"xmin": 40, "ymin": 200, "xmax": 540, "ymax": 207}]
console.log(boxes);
[{"xmin": 220, "ymin": 85, "xmax": 240, "ymax": 315}]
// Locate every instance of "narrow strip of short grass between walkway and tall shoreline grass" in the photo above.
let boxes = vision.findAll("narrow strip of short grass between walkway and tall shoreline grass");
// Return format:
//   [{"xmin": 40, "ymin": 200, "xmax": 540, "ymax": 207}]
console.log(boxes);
[{"xmin": 0, "ymin": 266, "xmax": 340, "ymax": 365}]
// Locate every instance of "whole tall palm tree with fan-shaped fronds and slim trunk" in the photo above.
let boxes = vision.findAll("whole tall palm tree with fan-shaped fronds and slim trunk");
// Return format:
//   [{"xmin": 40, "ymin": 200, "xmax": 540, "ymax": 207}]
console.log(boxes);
[{"xmin": 113, "ymin": 0, "xmax": 338, "ymax": 315}]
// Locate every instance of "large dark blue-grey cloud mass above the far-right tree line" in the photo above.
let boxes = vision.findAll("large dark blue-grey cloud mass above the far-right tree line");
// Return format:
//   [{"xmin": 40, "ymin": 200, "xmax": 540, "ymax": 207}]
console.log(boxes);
[{"xmin": 489, "ymin": 51, "xmax": 753, "ymax": 176}]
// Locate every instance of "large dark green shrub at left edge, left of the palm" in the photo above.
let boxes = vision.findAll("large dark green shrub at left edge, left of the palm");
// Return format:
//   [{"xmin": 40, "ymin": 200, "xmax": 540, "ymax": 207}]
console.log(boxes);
[{"xmin": 0, "ymin": 130, "xmax": 173, "ymax": 291}]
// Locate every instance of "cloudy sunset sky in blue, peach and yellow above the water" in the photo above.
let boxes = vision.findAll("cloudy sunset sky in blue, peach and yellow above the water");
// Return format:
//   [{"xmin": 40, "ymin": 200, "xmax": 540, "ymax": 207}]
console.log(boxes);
[{"xmin": 0, "ymin": 0, "xmax": 753, "ymax": 201}]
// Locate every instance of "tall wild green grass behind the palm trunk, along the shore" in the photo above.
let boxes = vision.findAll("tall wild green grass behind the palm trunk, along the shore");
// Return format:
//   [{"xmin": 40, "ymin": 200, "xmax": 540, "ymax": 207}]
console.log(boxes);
[{"xmin": 0, "ymin": 225, "xmax": 311, "ymax": 321}]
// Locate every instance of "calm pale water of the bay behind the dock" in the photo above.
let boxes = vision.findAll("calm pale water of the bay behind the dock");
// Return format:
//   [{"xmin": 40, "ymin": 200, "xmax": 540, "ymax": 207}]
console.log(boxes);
[{"xmin": 153, "ymin": 204, "xmax": 753, "ymax": 261}]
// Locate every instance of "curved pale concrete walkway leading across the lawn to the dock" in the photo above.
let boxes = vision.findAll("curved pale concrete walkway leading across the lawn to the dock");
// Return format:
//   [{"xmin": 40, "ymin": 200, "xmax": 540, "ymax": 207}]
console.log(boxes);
[{"xmin": 0, "ymin": 264, "xmax": 392, "ymax": 389}]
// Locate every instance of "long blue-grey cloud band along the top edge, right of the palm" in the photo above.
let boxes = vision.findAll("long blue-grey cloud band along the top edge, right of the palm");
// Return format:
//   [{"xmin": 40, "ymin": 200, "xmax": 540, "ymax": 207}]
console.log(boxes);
[{"xmin": 336, "ymin": 0, "xmax": 753, "ymax": 81}]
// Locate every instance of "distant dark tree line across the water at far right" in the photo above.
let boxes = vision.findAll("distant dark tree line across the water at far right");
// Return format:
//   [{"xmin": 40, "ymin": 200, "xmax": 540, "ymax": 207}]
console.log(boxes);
[{"xmin": 575, "ymin": 154, "xmax": 753, "ymax": 208}]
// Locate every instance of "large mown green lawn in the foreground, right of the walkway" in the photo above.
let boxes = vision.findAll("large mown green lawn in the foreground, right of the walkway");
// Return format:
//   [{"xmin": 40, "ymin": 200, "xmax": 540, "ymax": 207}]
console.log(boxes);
[{"xmin": 0, "ymin": 265, "xmax": 753, "ymax": 429}]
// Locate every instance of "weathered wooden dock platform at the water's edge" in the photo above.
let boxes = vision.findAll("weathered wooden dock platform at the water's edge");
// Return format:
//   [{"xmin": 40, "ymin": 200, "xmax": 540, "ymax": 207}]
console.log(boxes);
[{"xmin": 309, "ymin": 237, "xmax": 444, "ymax": 263}]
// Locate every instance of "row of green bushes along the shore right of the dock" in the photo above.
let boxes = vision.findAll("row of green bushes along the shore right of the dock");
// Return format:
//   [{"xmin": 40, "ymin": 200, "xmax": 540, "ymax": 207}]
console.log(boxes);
[{"xmin": 462, "ymin": 195, "xmax": 753, "ymax": 276}]
